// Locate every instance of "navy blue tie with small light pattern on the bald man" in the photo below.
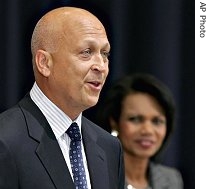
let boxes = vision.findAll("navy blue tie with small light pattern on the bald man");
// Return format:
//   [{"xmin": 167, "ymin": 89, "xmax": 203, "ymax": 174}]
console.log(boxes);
[{"xmin": 66, "ymin": 122, "xmax": 88, "ymax": 189}]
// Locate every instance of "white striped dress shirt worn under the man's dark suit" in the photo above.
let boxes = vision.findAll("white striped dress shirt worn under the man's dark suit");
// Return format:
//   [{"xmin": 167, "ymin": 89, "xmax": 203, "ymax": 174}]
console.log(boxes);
[{"xmin": 30, "ymin": 82, "xmax": 91, "ymax": 189}]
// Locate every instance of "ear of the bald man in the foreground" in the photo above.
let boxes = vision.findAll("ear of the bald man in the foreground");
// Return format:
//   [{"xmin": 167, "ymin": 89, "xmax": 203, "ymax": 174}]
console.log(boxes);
[{"xmin": 35, "ymin": 50, "xmax": 52, "ymax": 77}]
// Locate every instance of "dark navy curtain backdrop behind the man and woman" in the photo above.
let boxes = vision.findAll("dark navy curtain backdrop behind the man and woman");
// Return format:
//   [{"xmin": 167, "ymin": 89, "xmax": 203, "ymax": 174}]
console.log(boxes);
[{"xmin": 0, "ymin": 0, "xmax": 195, "ymax": 189}]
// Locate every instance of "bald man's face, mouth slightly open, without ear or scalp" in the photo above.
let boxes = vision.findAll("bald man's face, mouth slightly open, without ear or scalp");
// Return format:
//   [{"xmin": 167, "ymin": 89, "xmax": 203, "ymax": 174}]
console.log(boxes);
[{"xmin": 49, "ymin": 18, "xmax": 110, "ymax": 118}]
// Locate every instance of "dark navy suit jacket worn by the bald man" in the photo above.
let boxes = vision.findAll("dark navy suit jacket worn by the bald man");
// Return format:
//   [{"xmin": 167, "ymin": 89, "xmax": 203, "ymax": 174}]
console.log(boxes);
[{"xmin": 0, "ymin": 95, "xmax": 124, "ymax": 189}]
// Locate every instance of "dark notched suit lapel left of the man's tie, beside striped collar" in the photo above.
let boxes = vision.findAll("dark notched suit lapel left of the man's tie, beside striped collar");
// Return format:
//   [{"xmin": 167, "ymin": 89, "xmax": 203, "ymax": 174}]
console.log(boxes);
[{"xmin": 19, "ymin": 95, "xmax": 74, "ymax": 189}]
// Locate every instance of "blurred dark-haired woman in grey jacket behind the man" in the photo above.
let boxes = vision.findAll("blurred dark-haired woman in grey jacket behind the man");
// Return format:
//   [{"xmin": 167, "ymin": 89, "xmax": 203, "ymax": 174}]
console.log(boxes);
[{"xmin": 98, "ymin": 74, "xmax": 183, "ymax": 189}]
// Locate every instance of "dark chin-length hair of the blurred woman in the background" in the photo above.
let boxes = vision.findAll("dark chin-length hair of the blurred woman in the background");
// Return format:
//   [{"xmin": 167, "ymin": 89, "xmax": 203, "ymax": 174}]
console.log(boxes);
[{"xmin": 98, "ymin": 73, "xmax": 175, "ymax": 159}]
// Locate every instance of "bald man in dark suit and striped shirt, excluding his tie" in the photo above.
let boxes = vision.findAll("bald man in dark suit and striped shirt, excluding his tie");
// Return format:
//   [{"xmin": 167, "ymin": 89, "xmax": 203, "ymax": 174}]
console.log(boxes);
[{"xmin": 0, "ymin": 7, "xmax": 124, "ymax": 189}]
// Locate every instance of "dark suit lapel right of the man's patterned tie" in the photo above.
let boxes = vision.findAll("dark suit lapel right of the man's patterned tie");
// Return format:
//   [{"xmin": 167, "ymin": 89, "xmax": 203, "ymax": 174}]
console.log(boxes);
[{"xmin": 82, "ymin": 119, "xmax": 109, "ymax": 189}]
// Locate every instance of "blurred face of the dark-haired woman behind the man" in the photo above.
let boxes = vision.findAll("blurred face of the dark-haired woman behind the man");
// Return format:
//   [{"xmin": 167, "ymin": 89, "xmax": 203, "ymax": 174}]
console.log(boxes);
[{"xmin": 118, "ymin": 92, "xmax": 166, "ymax": 158}]
